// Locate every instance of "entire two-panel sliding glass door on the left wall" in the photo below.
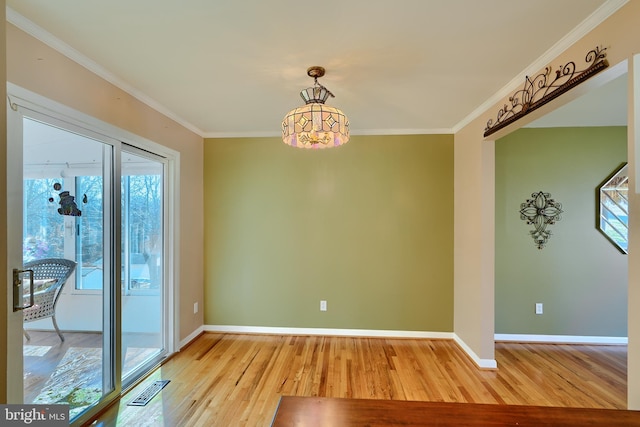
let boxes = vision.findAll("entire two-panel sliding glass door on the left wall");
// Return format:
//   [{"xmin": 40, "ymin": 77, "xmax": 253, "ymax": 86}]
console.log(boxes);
[{"xmin": 7, "ymin": 89, "xmax": 175, "ymax": 425}]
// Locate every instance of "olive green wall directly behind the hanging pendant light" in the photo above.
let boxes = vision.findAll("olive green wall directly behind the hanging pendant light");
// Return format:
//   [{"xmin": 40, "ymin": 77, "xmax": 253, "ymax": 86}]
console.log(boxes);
[{"xmin": 205, "ymin": 135, "xmax": 453, "ymax": 332}]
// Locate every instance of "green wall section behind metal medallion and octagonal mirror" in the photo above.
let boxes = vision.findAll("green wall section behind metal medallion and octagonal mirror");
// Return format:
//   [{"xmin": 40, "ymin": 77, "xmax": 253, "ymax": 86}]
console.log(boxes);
[{"xmin": 495, "ymin": 127, "xmax": 627, "ymax": 337}]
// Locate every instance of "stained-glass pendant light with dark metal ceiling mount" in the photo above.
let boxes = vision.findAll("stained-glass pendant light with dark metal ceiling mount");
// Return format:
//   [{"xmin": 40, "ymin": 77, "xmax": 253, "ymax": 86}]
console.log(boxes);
[{"xmin": 282, "ymin": 66, "xmax": 349, "ymax": 148}]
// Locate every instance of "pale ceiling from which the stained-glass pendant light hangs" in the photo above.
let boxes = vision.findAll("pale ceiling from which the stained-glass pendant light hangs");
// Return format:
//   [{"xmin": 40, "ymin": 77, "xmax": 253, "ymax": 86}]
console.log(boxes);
[{"xmin": 6, "ymin": 0, "xmax": 626, "ymax": 137}]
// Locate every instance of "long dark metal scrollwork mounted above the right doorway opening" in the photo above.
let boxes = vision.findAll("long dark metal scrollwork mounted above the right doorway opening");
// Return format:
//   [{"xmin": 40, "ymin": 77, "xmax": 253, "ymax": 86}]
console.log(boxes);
[{"xmin": 484, "ymin": 47, "xmax": 609, "ymax": 136}]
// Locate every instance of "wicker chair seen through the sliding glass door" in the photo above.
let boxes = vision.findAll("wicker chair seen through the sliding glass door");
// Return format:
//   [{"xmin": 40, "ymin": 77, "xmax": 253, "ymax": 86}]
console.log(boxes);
[{"xmin": 22, "ymin": 258, "xmax": 76, "ymax": 341}]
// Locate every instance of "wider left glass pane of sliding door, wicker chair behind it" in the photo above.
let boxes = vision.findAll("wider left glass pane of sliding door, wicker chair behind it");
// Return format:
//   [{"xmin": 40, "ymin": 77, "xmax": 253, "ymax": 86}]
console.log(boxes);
[{"xmin": 22, "ymin": 117, "xmax": 115, "ymax": 419}]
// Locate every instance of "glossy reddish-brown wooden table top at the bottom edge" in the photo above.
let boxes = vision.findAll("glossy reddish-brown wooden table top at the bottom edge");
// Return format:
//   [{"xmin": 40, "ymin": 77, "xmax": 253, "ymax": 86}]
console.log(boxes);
[{"xmin": 272, "ymin": 396, "xmax": 640, "ymax": 427}]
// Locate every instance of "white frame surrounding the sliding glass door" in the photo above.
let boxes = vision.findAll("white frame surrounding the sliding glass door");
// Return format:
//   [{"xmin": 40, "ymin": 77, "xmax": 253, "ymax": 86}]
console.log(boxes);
[{"xmin": 6, "ymin": 83, "xmax": 180, "ymax": 418}]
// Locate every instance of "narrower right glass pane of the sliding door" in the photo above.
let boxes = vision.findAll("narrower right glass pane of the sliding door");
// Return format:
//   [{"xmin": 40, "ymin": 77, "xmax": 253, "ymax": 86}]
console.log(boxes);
[{"xmin": 120, "ymin": 147, "xmax": 167, "ymax": 386}]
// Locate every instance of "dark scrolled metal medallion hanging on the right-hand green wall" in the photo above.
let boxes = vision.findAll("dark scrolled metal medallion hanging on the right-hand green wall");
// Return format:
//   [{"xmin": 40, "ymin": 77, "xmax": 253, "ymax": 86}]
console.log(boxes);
[{"xmin": 520, "ymin": 191, "xmax": 562, "ymax": 249}]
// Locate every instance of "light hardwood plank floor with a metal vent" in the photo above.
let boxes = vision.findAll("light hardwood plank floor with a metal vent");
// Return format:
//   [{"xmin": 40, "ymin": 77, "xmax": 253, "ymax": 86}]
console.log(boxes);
[{"xmin": 87, "ymin": 333, "xmax": 627, "ymax": 427}]
